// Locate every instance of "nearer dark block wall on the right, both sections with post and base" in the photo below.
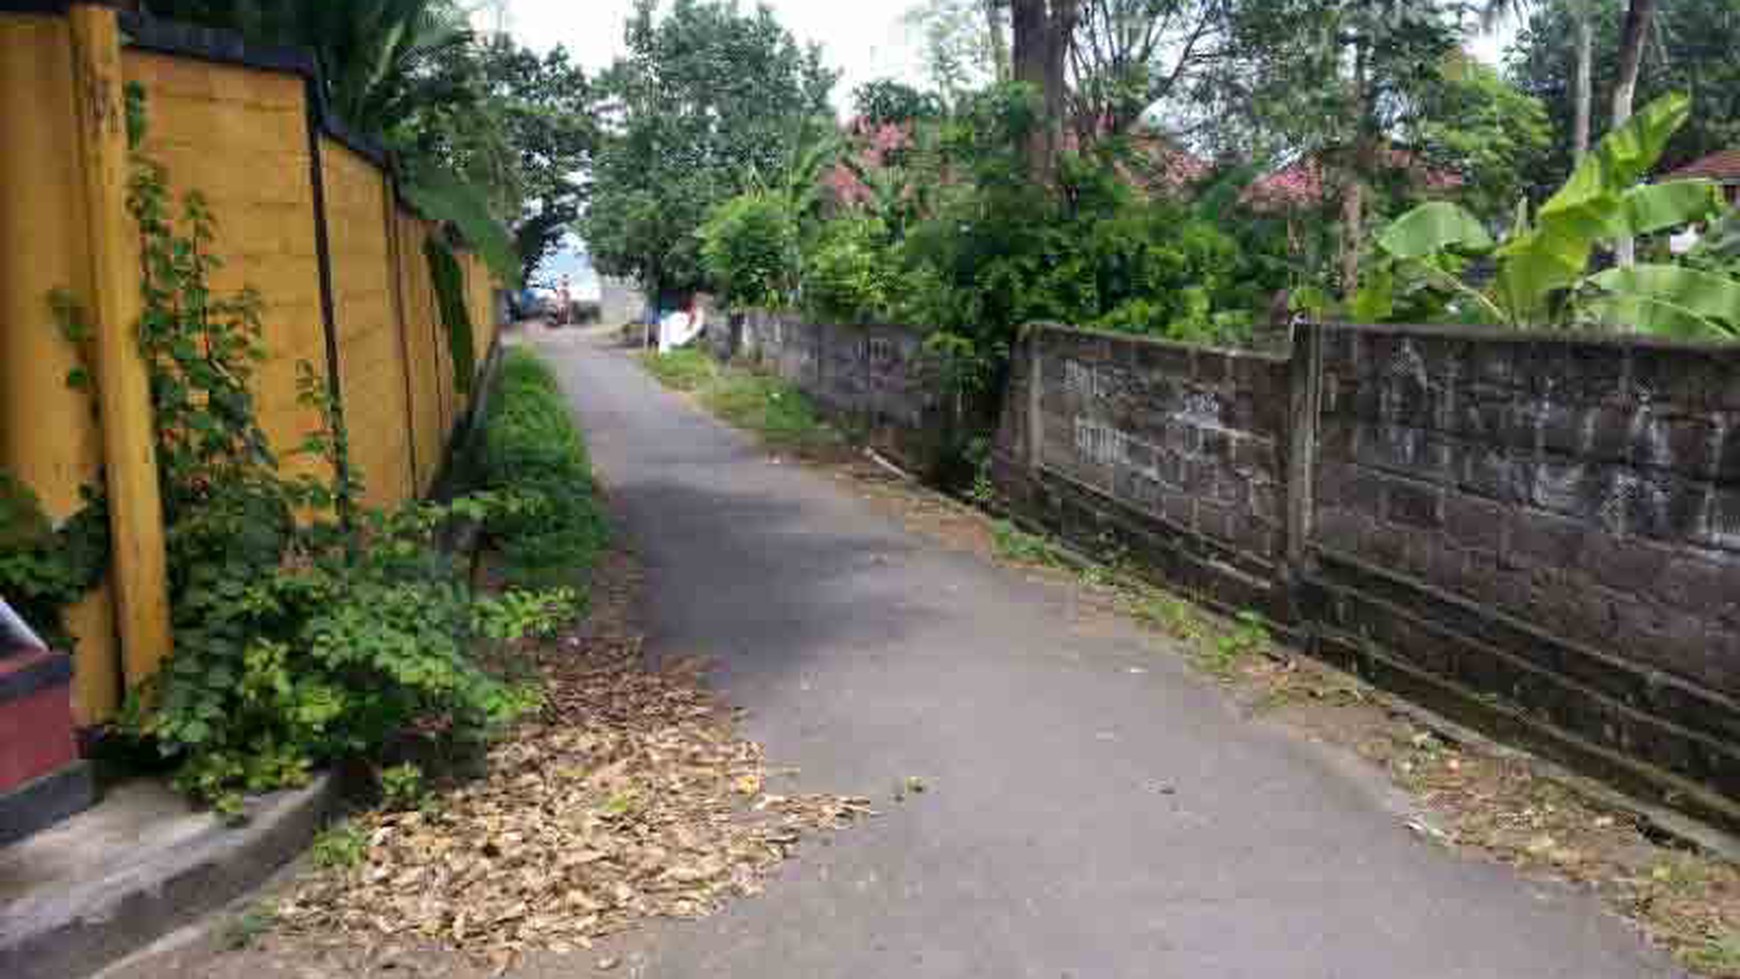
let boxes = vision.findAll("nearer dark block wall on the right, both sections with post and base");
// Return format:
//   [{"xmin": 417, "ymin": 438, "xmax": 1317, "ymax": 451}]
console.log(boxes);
[{"xmin": 994, "ymin": 327, "xmax": 1740, "ymax": 824}]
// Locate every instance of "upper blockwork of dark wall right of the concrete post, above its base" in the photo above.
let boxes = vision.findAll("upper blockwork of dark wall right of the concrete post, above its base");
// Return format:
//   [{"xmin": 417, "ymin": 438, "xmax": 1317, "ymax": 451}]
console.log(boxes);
[{"xmin": 1312, "ymin": 329, "xmax": 1740, "ymax": 696}]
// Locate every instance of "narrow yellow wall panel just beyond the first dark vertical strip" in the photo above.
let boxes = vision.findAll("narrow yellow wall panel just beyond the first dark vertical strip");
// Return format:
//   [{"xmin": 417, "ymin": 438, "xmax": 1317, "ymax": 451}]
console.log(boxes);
[{"xmin": 320, "ymin": 137, "xmax": 418, "ymax": 506}]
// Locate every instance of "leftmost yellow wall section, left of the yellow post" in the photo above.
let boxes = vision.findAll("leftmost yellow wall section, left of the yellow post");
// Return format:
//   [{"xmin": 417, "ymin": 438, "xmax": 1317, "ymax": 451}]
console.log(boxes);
[{"xmin": 0, "ymin": 16, "xmax": 122, "ymax": 723}]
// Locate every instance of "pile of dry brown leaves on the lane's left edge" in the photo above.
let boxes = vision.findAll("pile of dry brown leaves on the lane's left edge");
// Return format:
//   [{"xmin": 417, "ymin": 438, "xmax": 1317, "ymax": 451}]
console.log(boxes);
[{"xmin": 277, "ymin": 552, "xmax": 870, "ymax": 962}]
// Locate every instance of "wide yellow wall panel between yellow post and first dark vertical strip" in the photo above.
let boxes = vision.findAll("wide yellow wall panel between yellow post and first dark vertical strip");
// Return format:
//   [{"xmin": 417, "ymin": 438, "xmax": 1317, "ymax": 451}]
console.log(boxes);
[{"xmin": 124, "ymin": 50, "xmax": 335, "ymax": 490}]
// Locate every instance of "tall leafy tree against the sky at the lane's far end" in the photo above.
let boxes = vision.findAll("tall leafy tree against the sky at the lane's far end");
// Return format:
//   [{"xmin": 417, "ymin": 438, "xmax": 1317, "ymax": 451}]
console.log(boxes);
[{"xmin": 579, "ymin": 0, "xmax": 835, "ymax": 302}]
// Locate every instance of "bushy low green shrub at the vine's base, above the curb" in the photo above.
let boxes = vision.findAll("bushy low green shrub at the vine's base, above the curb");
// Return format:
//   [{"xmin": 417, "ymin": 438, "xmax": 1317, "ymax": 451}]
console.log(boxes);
[{"xmin": 138, "ymin": 499, "xmax": 574, "ymax": 812}]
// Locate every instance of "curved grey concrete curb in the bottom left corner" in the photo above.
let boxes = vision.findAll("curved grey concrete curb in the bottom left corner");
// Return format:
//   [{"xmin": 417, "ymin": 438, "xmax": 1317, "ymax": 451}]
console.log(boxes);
[{"xmin": 0, "ymin": 776, "xmax": 338, "ymax": 979}]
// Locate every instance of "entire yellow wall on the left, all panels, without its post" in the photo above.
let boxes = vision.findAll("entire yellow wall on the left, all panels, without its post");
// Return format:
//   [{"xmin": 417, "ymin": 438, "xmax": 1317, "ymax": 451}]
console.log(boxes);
[{"xmin": 0, "ymin": 14, "xmax": 494, "ymax": 723}]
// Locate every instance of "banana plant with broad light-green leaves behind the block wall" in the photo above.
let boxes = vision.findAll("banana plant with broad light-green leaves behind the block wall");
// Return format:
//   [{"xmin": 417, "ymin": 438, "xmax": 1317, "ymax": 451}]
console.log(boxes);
[{"xmin": 1352, "ymin": 96, "xmax": 1740, "ymax": 339}]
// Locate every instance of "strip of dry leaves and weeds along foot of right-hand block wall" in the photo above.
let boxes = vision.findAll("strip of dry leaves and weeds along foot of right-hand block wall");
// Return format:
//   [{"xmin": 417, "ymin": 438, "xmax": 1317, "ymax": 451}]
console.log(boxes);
[{"xmin": 835, "ymin": 462, "xmax": 1740, "ymax": 979}]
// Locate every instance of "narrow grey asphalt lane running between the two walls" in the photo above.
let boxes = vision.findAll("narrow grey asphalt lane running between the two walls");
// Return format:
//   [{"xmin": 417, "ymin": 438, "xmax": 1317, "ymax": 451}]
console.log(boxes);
[{"xmin": 541, "ymin": 334, "xmax": 1676, "ymax": 979}]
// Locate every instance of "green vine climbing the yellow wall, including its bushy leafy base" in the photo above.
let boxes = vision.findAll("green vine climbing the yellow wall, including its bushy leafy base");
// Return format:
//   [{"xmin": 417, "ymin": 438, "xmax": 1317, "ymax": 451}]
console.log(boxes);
[{"xmin": 122, "ymin": 97, "xmax": 574, "ymax": 812}]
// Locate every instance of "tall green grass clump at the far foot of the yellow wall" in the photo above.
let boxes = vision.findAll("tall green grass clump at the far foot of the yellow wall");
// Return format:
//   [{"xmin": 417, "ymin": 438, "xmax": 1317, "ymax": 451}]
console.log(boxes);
[{"xmin": 479, "ymin": 350, "xmax": 609, "ymax": 586}]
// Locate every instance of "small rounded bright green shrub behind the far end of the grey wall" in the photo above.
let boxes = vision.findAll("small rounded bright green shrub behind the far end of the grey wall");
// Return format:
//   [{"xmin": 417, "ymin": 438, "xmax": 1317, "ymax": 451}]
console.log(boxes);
[{"xmin": 699, "ymin": 193, "xmax": 797, "ymax": 306}]
